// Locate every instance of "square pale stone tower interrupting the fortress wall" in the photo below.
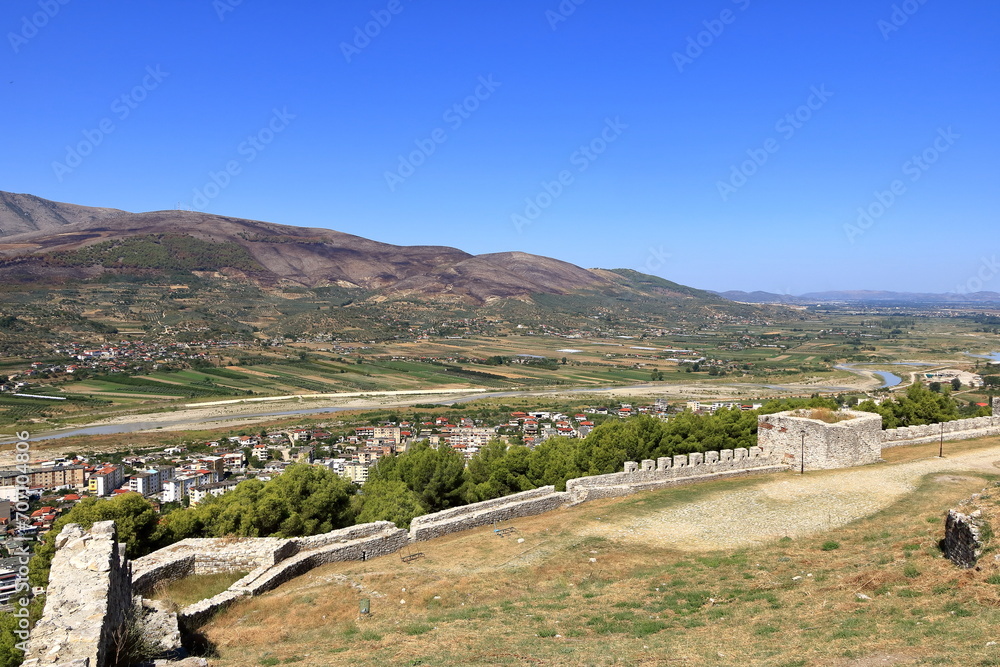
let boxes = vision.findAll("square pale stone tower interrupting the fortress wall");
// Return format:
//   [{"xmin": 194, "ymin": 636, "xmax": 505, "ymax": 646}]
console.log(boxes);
[{"xmin": 757, "ymin": 410, "xmax": 882, "ymax": 470}]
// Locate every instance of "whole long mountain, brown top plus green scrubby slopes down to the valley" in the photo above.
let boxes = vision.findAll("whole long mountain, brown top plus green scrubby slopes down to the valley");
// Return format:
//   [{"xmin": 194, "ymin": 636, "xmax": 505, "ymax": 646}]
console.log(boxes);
[{"xmin": 0, "ymin": 193, "xmax": 774, "ymax": 337}]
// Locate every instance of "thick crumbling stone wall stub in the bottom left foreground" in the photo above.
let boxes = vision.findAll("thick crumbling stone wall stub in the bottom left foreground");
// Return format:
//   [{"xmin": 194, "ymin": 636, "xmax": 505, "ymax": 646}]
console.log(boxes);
[{"xmin": 24, "ymin": 521, "xmax": 132, "ymax": 667}]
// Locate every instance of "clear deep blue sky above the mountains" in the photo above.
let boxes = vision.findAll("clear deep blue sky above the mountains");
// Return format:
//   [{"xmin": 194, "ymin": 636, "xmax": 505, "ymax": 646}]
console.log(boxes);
[{"xmin": 0, "ymin": 0, "xmax": 1000, "ymax": 293}]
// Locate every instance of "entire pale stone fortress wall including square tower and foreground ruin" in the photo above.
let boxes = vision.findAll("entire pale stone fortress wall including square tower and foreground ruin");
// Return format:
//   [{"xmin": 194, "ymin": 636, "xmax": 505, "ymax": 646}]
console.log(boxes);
[{"xmin": 24, "ymin": 398, "xmax": 1000, "ymax": 667}]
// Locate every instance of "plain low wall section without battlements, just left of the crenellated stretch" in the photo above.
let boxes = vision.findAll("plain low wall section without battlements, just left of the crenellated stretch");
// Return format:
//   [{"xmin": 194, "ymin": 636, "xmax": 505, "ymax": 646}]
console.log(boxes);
[{"xmin": 410, "ymin": 486, "xmax": 569, "ymax": 542}]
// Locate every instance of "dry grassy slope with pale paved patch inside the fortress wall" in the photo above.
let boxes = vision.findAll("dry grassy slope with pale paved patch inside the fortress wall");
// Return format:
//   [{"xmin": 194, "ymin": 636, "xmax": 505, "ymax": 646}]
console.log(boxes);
[{"xmin": 204, "ymin": 438, "xmax": 1000, "ymax": 667}]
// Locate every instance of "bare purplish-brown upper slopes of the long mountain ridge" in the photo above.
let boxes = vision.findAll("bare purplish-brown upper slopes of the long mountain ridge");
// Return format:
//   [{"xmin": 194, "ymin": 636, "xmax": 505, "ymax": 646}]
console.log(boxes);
[{"xmin": 0, "ymin": 193, "xmax": 737, "ymax": 308}]
